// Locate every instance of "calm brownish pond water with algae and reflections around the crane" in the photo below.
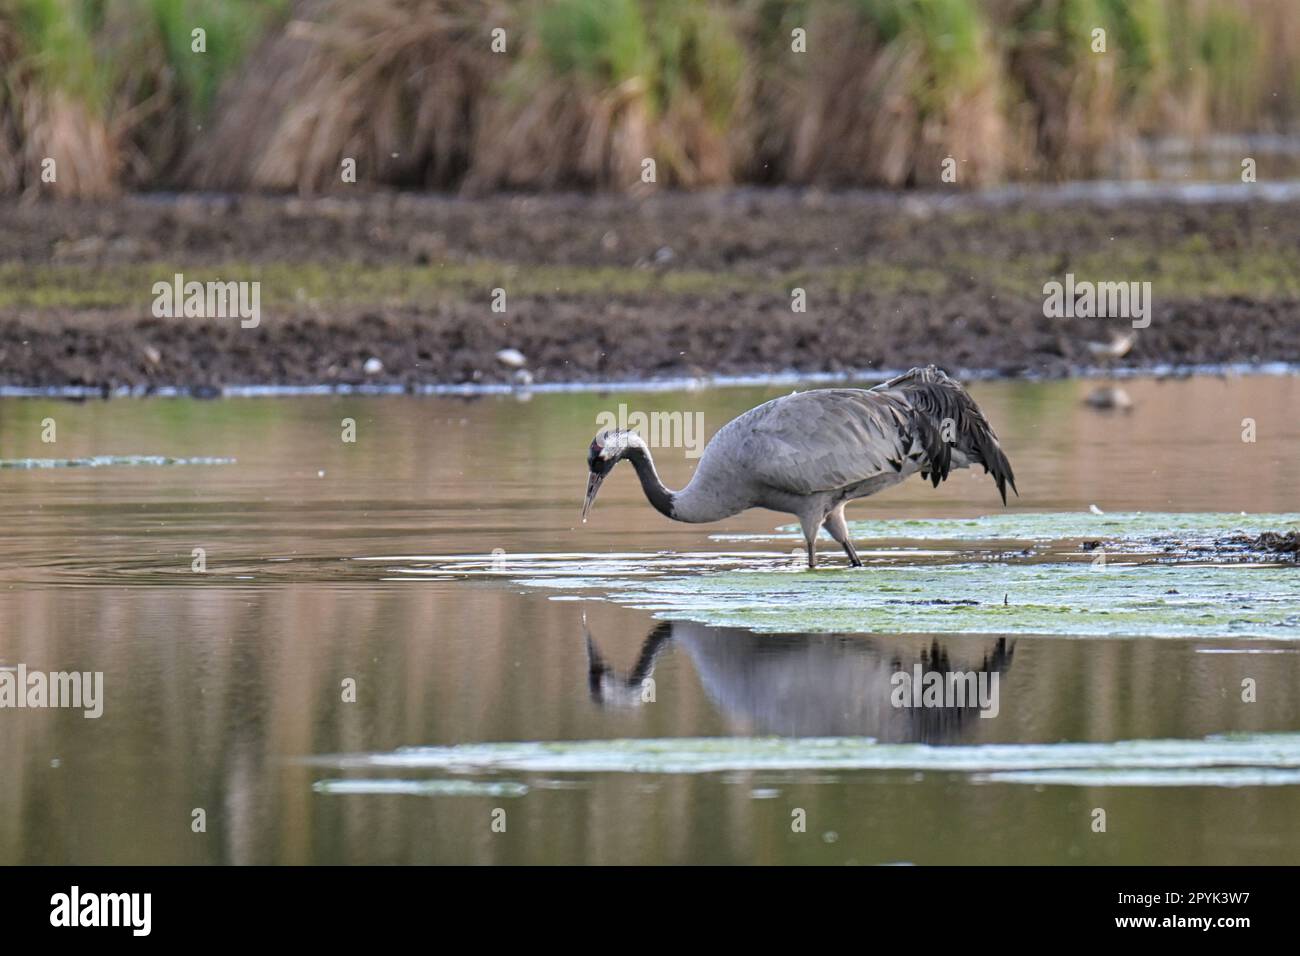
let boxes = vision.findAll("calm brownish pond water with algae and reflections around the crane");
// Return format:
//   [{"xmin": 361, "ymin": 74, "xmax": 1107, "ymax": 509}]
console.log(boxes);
[{"xmin": 0, "ymin": 376, "xmax": 1300, "ymax": 864}]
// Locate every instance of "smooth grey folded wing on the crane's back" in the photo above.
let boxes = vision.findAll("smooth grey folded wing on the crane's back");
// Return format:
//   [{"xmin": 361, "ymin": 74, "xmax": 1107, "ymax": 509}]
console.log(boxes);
[{"xmin": 727, "ymin": 389, "xmax": 911, "ymax": 494}]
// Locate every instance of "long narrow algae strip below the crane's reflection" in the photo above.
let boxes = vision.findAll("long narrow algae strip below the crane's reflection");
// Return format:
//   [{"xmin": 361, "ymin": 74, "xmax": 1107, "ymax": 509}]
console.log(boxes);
[{"xmin": 313, "ymin": 734, "xmax": 1300, "ymax": 786}]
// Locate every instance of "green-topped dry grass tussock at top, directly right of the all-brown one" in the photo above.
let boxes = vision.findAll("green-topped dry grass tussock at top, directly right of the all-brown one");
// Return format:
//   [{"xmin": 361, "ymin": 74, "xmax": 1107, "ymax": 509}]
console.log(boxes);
[{"xmin": 465, "ymin": 0, "xmax": 749, "ymax": 191}]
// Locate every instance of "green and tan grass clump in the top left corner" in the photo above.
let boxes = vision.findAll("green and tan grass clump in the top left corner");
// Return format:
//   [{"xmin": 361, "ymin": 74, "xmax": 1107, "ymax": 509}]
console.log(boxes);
[{"xmin": 0, "ymin": 0, "xmax": 283, "ymax": 198}]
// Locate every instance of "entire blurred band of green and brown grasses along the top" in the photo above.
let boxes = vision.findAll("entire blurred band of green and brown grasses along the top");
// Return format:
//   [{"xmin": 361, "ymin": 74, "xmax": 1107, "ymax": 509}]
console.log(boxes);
[{"xmin": 0, "ymin": 0, "xmax": 1300, "ymax": 196}]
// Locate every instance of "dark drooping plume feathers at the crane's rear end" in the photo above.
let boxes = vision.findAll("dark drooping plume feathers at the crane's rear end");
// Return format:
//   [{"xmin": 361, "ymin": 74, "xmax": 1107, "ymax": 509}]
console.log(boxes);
[{"xmin": 876, "ymin": 365, "xmax": 1021, "ymax": 505}]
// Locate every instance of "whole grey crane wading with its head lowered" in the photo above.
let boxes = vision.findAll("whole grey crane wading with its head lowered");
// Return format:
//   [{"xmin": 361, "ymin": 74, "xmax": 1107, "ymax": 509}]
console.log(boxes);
[{"xmin": 582, "ymin": 365, "xmax": 1019, "ymax": 567}]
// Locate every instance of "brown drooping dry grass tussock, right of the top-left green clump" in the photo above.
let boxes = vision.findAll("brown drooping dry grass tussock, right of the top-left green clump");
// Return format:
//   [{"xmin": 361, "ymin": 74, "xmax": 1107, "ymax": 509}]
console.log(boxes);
[{"xmin": 187, "ymin": 0, "xmax": 501, "ymax": 193}]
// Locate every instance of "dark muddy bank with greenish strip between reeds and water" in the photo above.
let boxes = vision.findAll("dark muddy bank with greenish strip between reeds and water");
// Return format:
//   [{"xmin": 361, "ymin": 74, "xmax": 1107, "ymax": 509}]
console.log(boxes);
[{"xmin": 0, "ymin": 191, "xmax": 1300, "ymax": 389}]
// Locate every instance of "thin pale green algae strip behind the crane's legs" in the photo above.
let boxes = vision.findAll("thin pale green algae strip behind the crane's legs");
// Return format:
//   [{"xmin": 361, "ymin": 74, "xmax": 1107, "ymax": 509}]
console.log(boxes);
[{"xmin": 743, "ymin": 511, "xmax": 1300, "ymax": 541}]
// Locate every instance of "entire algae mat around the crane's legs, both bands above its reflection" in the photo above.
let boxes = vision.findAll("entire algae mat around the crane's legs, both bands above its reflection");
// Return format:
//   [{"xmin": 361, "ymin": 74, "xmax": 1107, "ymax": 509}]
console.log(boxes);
[{"xmin": 410, "ymin": 512, "xmax": 1300, "ymax": 640}]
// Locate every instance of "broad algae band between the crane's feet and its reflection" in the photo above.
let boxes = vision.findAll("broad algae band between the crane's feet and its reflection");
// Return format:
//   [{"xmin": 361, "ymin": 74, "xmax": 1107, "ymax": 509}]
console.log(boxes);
[{"xmin": 529, "ymin": 561, "xmax": 1300, "ymax": 640}]
